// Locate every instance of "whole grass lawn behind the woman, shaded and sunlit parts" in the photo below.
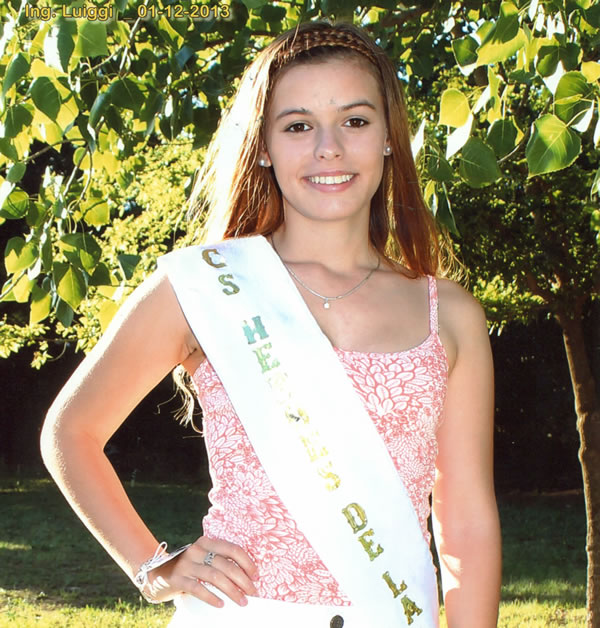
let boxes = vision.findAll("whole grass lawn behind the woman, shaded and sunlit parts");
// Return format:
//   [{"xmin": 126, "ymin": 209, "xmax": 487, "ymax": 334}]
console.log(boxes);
[{"xmin": 0, "ymin": 478, "xmax": 585, "ymax": 628}]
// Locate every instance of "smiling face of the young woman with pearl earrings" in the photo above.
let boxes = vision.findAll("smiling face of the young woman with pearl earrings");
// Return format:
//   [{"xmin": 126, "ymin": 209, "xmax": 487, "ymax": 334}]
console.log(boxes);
[{"xmin": 263, "ymin": 59, "xmax": 387, "ymax": 228}]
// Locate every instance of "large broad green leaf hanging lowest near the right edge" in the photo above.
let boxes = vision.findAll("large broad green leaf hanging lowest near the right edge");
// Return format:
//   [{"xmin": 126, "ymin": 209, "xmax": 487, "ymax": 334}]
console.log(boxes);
[{"xmin": 525, "ymin": 114, "xmax": 581, "ymax": 176}]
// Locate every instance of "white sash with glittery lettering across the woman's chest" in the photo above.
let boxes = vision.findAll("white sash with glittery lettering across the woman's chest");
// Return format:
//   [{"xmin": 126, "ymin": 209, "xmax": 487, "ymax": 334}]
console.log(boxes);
[{"xmin": 159, "ymin": 236, "xmax": 438, "ymax": 628}]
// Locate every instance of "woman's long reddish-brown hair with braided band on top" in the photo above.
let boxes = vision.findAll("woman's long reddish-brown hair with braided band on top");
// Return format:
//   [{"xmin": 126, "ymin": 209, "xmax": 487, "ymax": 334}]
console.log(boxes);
[{"xmin": 190, "ymin": 22, "xmax": 441, "ymax": 275}]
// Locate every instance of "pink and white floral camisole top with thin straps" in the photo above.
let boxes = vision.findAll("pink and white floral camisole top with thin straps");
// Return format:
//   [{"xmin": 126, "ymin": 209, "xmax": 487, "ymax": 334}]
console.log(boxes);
[{"xmin": 193, "ymin": 277, "xmax": 448, "ymax": 605}]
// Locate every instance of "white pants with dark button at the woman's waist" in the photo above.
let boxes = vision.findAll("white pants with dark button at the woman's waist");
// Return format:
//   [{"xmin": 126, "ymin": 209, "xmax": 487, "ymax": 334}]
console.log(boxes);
[{"xmin": 169, "ymin": 594, "xmax": 370, "ymax": 628}]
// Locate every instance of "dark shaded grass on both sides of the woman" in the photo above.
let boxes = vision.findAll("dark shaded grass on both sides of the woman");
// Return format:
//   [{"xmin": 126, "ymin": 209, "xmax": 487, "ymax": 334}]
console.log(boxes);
[{"xmin": 0, "ymin": 478, "xmax": 585, "ymax": 609}]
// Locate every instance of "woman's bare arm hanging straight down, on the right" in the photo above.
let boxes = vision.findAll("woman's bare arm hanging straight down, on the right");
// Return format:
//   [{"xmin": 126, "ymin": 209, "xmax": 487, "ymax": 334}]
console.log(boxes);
[{"xmin": 433, "ymin": 282, "xmax": 501, "ymax": 628}]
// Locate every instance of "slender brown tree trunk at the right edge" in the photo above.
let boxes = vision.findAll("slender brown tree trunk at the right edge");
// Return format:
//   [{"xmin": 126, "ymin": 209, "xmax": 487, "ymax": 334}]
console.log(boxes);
[{"xmin": 556, "ymin": 306, "xmax": 600, "ymax": 628}]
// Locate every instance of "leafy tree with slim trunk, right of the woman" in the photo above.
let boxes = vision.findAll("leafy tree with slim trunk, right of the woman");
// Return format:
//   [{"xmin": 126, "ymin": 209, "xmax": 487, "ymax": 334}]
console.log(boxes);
[{"xmin": 404, "ymin": 2, "xmax": 600, "ymax": 627}]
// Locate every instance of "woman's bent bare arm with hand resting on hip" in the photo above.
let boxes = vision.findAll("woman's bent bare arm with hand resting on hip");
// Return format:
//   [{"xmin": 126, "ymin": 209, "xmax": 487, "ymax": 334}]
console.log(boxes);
[{"xmin": 41, "ymin": 273, "xmax": 254, "ymax": 604}]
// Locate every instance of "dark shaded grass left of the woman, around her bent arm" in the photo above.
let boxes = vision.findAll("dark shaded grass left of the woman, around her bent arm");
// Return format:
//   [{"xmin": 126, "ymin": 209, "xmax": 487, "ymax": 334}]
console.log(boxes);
[{"xmin": 0, "ymin": 480, "xmax": 208, "ymax": 608}]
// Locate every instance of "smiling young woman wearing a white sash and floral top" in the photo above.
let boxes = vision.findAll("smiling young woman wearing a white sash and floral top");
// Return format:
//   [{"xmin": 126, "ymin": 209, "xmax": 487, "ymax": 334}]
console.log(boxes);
[{"xmin": 42, "ymin": 23, "xmax": 500, "ymax": 628}]
